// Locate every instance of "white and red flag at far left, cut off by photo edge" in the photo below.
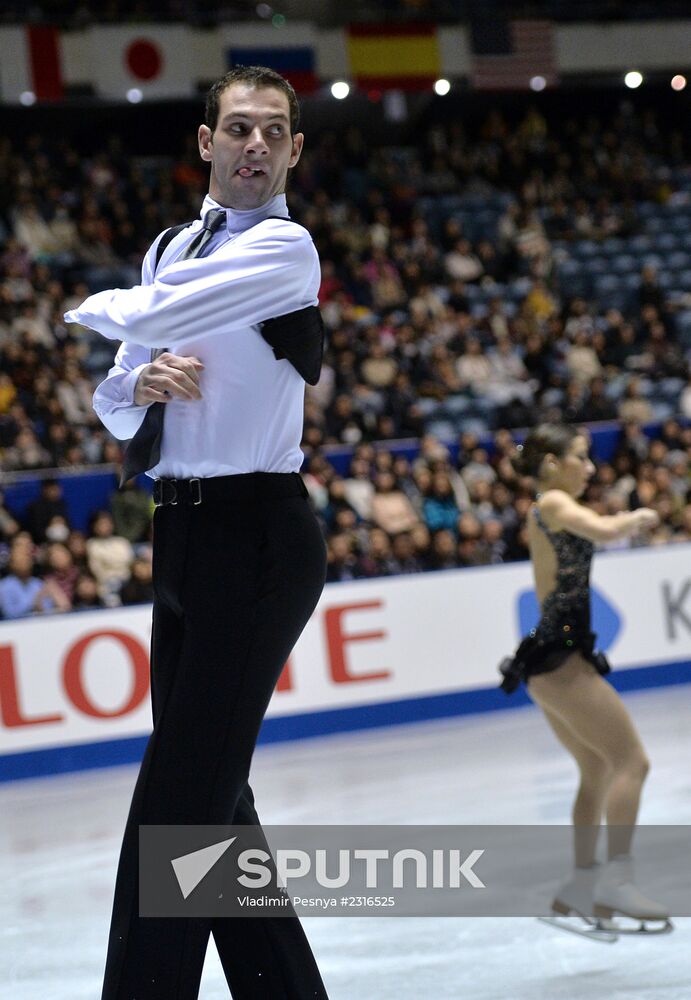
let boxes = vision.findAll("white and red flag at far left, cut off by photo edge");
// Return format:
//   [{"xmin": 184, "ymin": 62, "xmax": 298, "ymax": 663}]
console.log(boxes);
[{"xmin": 0, "ymin": 24, "xmax": 63, "ymax": 104}]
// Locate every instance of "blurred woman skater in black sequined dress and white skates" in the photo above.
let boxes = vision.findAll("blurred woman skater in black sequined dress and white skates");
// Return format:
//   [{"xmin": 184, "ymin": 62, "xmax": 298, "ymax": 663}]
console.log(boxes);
[{"xmin": 500, "ymin": 424, "xmax": 670, "ymax": 930}]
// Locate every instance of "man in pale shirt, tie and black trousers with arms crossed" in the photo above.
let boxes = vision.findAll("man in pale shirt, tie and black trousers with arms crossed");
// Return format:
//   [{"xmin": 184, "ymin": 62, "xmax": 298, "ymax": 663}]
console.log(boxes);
[{"xmin": 66, "ymin": 67, "xmax": 326, "ymax": 1000}]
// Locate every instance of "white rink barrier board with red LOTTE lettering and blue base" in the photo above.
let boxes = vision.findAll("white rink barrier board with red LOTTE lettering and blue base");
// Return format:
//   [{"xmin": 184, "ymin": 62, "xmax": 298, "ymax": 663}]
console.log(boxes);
[{"xmin": 0, "ymin": 543, "xmax": 691, "ymax": 780}]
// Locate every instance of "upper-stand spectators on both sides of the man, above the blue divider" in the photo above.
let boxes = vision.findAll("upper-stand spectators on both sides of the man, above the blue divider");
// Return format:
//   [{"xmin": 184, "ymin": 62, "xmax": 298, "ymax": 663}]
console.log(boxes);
[{"xmin": 5, "ymin": 103, "xmax": 691, "ymax": 470}]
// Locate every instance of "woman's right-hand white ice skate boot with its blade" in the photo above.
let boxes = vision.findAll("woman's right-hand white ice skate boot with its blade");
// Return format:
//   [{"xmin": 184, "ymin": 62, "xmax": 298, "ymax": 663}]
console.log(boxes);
[{"xmin": 593, "ymin": 854, "xmax": 673, "ymax": 934}]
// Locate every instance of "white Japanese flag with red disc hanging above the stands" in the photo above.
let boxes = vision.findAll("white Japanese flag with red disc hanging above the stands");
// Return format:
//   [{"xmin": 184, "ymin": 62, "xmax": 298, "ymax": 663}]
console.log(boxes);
[{"xmin": 89, "ymin": 24, "xmax": 195, "ymax": 100}]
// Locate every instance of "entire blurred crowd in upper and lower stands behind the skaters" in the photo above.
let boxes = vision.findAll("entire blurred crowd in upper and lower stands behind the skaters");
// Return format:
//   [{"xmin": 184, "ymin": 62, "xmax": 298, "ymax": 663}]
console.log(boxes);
[{"xmin": 0, "ymin": 101, "xmax": 691, "ymax": 610}]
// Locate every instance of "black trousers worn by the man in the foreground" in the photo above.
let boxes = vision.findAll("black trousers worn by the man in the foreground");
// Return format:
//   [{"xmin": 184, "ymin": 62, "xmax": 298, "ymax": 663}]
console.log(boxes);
[{"xmin": 102, "ymin": 473, "xmax": 327, "ymax": 1000}]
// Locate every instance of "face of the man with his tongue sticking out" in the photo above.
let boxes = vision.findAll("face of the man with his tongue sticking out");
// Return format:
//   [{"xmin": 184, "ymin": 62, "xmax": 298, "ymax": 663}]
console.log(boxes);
[{"xmin": 199, "ymin": 83, "xmax": 304, "ymax": 210}]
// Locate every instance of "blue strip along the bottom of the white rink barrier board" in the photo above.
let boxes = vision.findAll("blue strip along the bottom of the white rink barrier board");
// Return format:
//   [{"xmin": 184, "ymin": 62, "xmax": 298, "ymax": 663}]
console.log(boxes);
[{"xmin": 0, "ymin": 660, "xmax": 691, "ymax": 783}]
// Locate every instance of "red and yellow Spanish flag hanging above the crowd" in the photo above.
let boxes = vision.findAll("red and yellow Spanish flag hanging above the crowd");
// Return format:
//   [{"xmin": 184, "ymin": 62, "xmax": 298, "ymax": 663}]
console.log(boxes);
[{"xmin": 348, "ymin": 24, "xmax": 441, "ymax": 90}]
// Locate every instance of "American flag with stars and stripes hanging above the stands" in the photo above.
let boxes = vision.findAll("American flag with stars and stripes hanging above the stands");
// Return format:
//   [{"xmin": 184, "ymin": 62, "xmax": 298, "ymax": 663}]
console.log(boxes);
[{"xmin": 471, "ymin": 21, "xmax": 557, "ymax": 90}]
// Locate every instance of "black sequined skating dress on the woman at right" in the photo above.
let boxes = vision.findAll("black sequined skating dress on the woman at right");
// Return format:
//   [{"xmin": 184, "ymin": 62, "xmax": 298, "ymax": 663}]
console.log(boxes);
[{"xmin": 499, "ymin": 507, "xmax": 610, "ymax": 694}]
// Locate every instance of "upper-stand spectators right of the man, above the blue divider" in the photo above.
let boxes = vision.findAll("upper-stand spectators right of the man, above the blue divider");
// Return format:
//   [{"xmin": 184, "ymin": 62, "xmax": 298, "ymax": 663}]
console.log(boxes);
[{"xmin": 304, "ymin": 104, "xmax": 691, "ymax": 444}]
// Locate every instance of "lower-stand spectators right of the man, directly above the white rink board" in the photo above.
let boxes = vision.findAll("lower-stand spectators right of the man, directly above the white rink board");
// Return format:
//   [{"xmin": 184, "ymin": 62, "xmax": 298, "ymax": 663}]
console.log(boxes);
[{"xmin": 312, "ymin": 420, "xmax": 691, "ymax": 581}]
